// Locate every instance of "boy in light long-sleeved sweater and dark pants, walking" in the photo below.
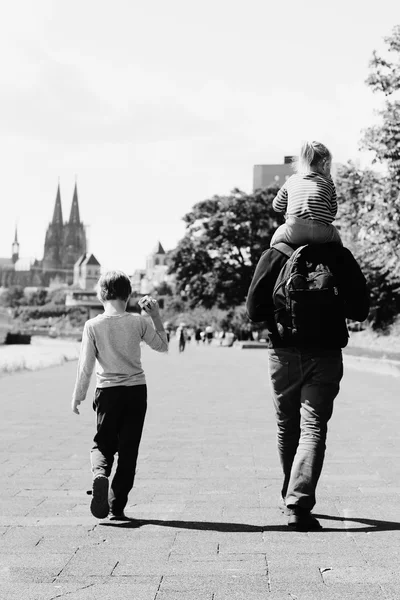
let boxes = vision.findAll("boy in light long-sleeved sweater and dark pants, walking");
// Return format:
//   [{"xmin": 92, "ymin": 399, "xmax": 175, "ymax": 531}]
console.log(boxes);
[{"xmin": 72, "ymin": 271, "xmax": 168, "ymax": 520}]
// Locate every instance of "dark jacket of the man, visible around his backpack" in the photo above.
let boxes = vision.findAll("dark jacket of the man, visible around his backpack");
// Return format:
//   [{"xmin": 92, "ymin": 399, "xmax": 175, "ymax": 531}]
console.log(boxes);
[{"xmin": 246, "ymin": 243, "xmax": 369, "ymax": 348}]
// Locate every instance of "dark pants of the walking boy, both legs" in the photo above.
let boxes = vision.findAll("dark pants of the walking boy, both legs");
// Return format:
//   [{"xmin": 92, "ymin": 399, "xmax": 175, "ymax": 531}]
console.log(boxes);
[{"xmin": 90, "ymin": 385, "xmax": 147, "ymax": 514}]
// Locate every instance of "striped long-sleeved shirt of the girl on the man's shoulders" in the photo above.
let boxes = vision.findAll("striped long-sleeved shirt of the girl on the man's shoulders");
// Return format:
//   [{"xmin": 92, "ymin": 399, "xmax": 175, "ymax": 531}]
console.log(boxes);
[{"xmin": 272, "ymin": 172, "xmax": 337, "ymax": 225}]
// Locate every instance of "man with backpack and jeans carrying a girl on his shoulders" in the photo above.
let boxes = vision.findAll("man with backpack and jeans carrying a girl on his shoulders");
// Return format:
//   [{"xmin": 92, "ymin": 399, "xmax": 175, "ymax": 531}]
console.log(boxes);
[{"xmin": 247, "ymin": 243, "xmax": 369, "ymax": 530}]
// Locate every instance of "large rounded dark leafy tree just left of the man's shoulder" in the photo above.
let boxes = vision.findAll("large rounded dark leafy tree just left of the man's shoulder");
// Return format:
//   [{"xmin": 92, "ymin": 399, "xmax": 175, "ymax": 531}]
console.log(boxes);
[{"xmin": 170, "ymin": 188, "xmax": 283, "ymax": 308}]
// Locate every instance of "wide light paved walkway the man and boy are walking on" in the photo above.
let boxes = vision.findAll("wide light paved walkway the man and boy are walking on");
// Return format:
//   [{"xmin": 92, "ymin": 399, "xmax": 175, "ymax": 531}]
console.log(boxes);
[{"xmin": 0, "ymin": 343, "xmax": 400, "ymax": 600}]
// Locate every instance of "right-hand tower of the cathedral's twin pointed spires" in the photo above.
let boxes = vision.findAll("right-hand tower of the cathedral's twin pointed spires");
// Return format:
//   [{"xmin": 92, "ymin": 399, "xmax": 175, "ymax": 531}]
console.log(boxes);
[{"xmin": 61, "ymin": 183, "xmax": 86, "ymax": 283}]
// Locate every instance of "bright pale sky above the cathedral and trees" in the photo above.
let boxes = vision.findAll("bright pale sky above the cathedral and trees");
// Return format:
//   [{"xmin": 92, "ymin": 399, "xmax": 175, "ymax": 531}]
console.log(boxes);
[{"xmin": 0, "ymin": 0, "xmax": 400, "ymax": 274}]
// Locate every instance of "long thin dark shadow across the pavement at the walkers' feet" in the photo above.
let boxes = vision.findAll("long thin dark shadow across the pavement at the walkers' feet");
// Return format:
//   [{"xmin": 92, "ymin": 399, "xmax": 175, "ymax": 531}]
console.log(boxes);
[{"xmin": 100, "ymin": 513, "xmax": 400, "ymax": 533}]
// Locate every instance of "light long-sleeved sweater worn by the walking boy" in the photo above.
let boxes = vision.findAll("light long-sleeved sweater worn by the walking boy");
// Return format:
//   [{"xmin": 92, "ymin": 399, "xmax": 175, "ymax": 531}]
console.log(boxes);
[{"xmin": 73, "ymin": 312, "xmax": 168, "ymax": 402}]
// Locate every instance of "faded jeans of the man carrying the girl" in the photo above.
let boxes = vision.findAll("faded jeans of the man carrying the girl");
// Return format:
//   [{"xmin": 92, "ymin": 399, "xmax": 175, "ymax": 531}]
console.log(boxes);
[{"xmin": 268, "ymin": 348, "xmax": 343, "ymax": 510}]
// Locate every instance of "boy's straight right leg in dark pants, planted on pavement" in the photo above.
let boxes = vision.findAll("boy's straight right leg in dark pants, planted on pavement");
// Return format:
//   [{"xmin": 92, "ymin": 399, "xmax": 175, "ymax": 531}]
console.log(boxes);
[{"xmin": 109, "ymin": 385, "xmax": 147, "ymax": 515}]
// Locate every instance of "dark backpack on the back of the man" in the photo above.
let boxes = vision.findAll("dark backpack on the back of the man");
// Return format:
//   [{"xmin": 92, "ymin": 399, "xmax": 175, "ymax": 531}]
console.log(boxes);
[{"xmin": 272, "ymin": 243, "xmax": 345, "ymax": 347}]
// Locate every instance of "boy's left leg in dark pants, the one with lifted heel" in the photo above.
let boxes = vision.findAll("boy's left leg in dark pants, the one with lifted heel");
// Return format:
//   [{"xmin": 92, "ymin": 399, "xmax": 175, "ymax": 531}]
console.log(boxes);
[{"xmin": 90, "ymin": 386, "xmax": 121, "ymax": 477}]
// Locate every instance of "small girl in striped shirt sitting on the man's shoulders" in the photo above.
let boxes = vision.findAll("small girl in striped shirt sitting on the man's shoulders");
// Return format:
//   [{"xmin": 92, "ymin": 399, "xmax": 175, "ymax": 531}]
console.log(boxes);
[{"xmin": 271, "ymin": 141, "xmax": 342, "ymax": 246}]
